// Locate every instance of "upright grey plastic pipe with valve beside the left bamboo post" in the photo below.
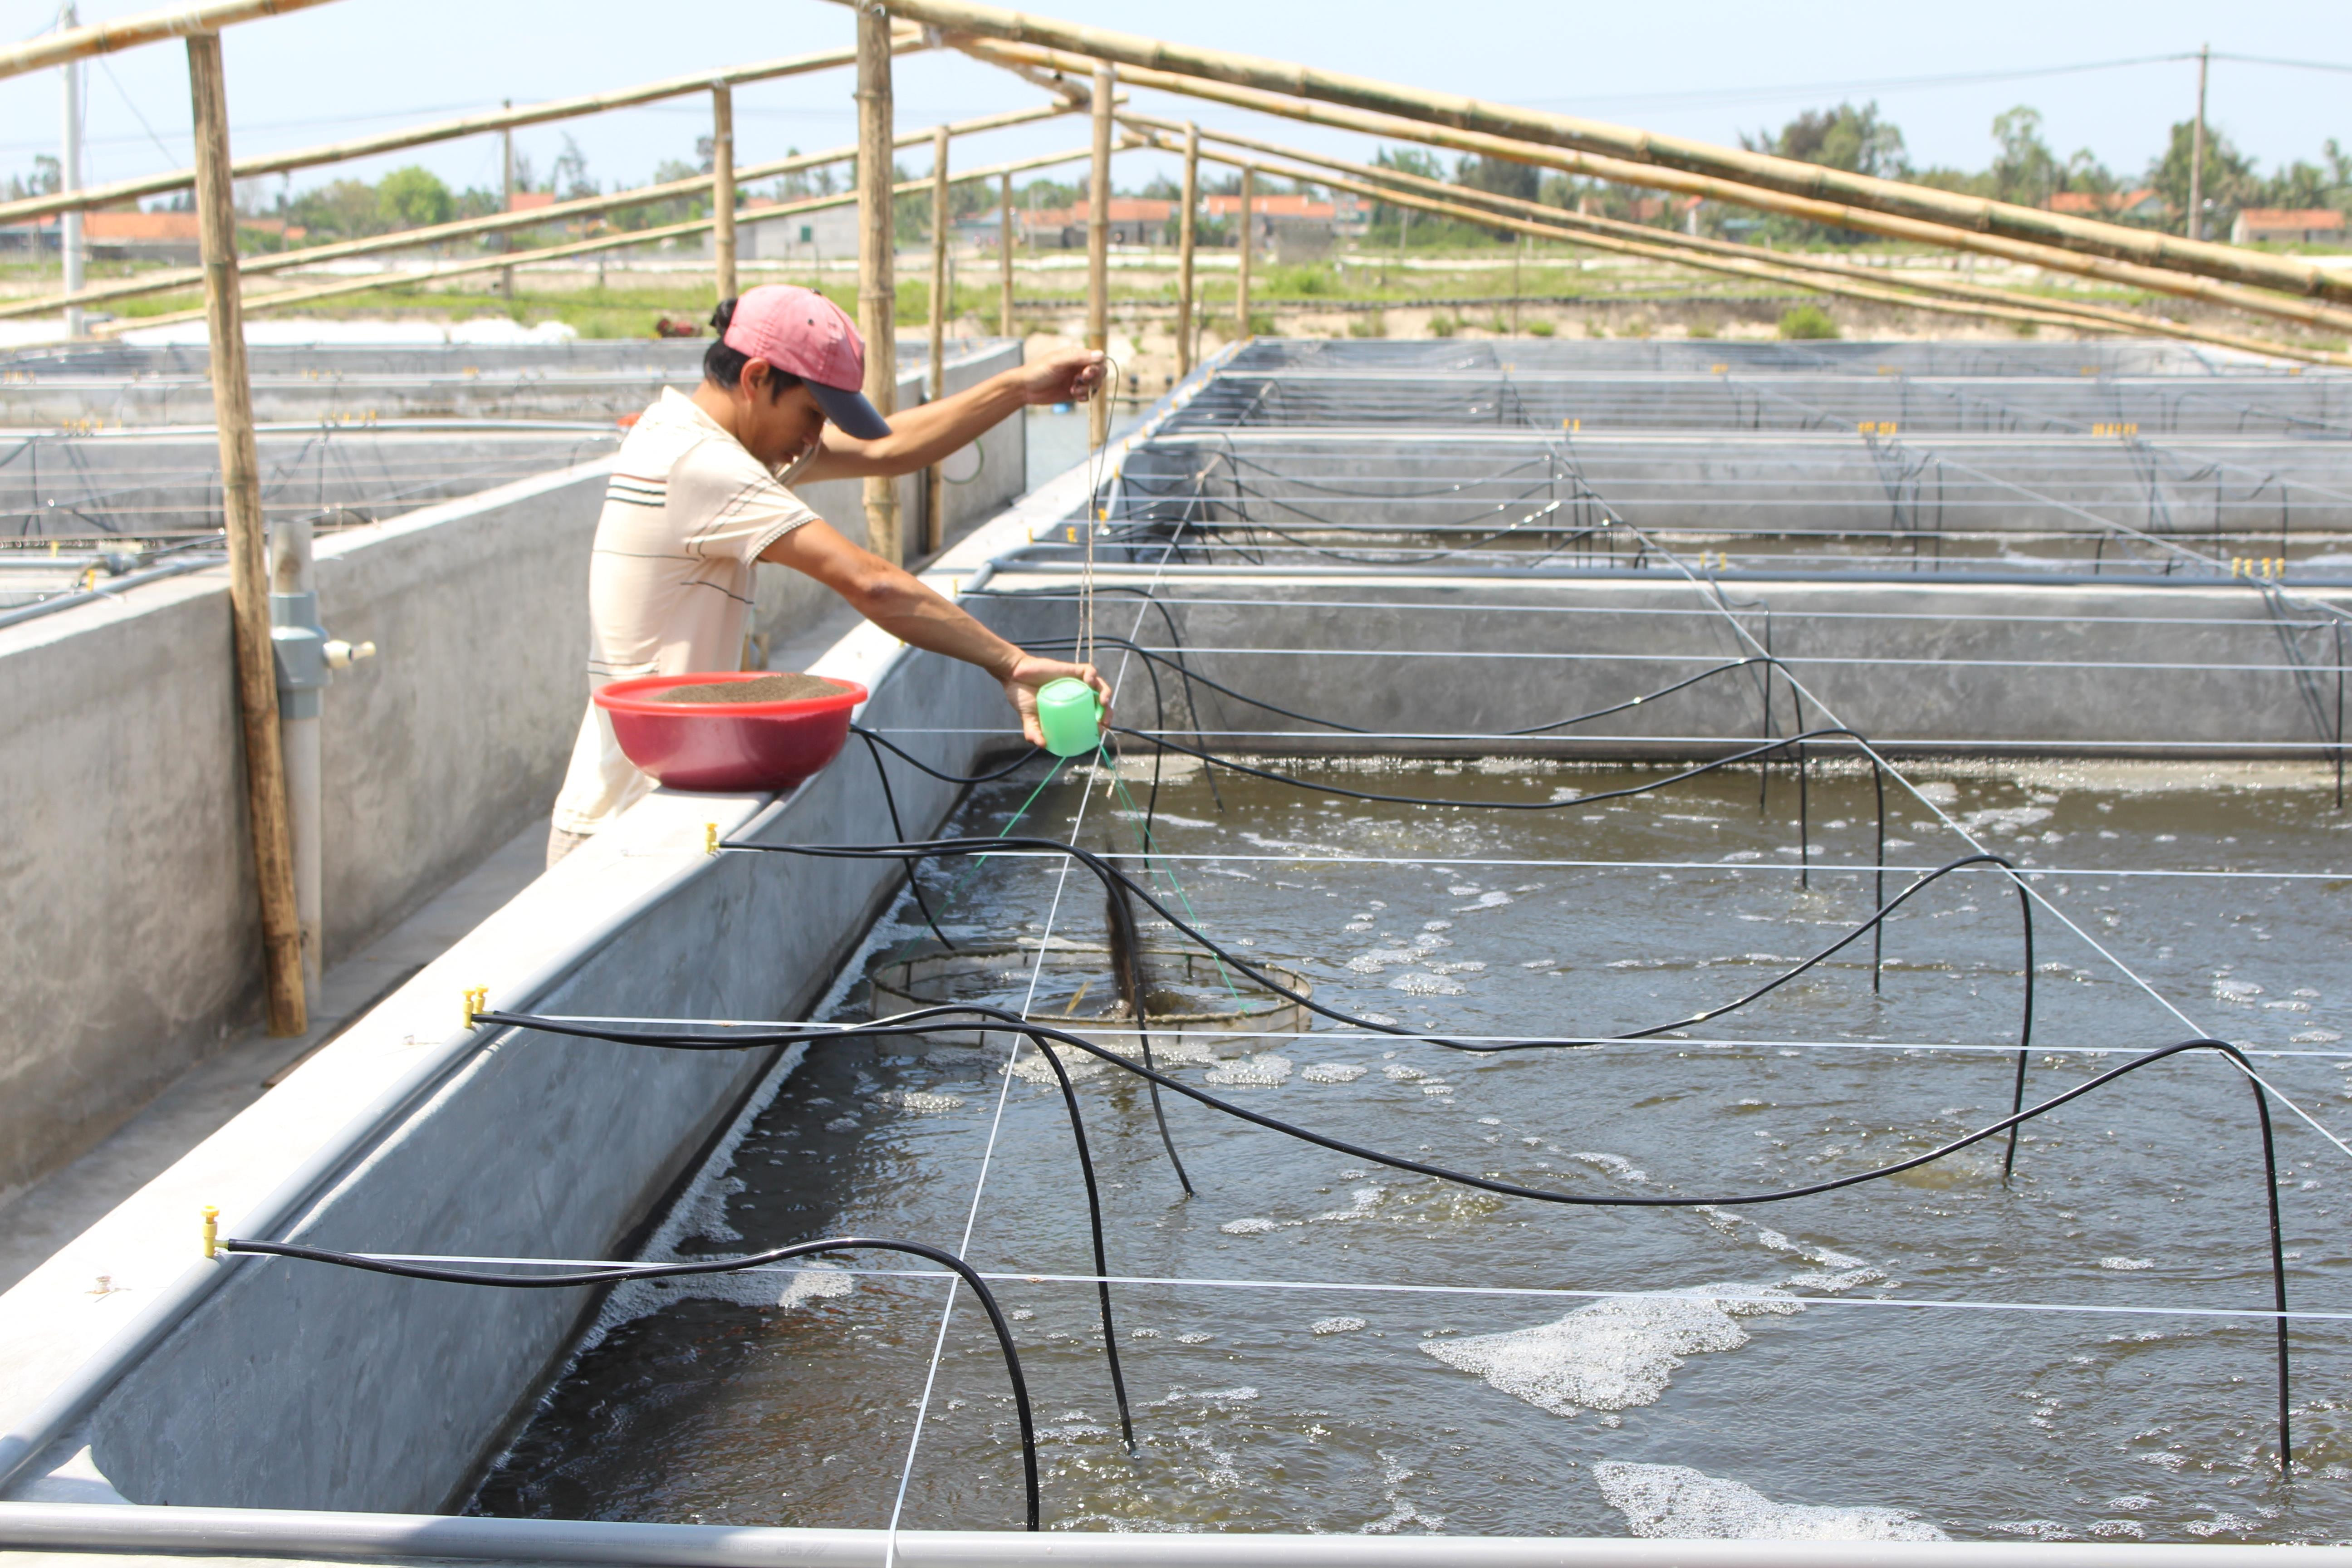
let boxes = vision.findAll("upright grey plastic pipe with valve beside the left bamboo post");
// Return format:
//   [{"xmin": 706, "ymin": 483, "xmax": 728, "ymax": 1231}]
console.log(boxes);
[{"xmin": 270, "ymin": 517, "xmax": 376, "ymax": 995}]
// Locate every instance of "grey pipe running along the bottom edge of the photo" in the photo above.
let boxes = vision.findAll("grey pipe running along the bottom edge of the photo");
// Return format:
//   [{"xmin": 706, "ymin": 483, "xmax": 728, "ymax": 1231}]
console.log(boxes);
[{"xmin": 0, "ymin": 1502, "xmax": 2352, "ymax": 1568}]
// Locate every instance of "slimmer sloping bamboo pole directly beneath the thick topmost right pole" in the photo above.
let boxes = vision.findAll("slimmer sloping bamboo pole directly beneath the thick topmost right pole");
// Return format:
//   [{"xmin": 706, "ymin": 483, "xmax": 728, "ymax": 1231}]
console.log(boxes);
[{"xmin": 960, "ymin": 44, "xmax": 2352, "ymax": 343}]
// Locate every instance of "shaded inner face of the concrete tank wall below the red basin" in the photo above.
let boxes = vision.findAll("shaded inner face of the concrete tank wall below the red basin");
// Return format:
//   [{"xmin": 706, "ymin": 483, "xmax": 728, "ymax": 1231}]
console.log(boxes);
[{"xmin": 82, "ymin": 611, "xmax": 1007, "ymax": 1509}]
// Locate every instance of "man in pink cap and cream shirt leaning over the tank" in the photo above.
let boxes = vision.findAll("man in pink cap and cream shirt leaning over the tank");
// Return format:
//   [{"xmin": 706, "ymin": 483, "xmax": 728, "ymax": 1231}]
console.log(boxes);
[{"xmin": 548, "ymin": 284, "xmax": 1110, "ymax": 865}]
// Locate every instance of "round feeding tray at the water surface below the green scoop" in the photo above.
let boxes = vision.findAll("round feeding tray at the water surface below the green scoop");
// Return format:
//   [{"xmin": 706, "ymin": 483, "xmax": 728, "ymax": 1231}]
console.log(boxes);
[{"xmin": 866, "ymin": 941, "xmax": 1315, "ymax": 1055}]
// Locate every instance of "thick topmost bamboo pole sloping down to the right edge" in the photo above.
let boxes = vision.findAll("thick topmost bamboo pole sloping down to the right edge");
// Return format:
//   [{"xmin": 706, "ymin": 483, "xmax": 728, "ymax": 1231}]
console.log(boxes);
[{"xmin": 884, "ymin": 0, "xmax": 2352, "ymax": 301}]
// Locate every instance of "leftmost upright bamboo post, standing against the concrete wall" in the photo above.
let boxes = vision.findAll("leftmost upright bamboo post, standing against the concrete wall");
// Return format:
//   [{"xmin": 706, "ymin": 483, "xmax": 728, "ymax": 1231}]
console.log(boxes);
[{"xmin": 188, "ymin": 33, "xmax": 308, "ymax": 1037}]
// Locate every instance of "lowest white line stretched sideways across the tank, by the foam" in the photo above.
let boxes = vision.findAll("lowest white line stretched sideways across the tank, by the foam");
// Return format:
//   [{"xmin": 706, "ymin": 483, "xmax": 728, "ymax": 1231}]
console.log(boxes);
[{"xmin": 336, "ymin": 1253, "xmax": 2352, "ymax": 1323}]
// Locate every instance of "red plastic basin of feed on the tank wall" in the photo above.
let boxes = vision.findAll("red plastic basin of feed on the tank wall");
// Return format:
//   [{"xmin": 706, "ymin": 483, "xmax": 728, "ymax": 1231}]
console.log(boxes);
[{"xmin": 595, "ymin": 670, "xmax": 868, "ymax": 794}]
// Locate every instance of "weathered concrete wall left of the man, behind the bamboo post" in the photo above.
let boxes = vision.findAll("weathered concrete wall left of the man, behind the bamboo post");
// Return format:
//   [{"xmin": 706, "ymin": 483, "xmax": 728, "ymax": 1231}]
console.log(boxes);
[{"xmin": 0, "ymin": 463, "xmax": 604, "ymax": 1187}]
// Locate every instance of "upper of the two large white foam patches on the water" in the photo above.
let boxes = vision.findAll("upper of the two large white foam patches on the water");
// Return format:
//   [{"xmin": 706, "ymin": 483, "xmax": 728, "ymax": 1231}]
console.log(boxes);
[{"xmin": 1421, "ymin": 1284, "xmax": 1804, "ymax": 1415}]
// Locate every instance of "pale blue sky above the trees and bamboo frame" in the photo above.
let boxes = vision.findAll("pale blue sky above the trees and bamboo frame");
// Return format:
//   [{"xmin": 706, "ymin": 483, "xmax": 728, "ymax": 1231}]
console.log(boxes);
[{"xmin": 0, "ymin": 0, "xmax": 2352, "ymax": 208}]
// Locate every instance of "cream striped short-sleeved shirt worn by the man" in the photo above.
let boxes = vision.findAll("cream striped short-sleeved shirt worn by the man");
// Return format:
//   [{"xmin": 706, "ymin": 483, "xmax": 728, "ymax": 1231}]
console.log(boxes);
[{"xmin": 555, "ymin": 388, "xmax": 816, "ymax": 832}]
